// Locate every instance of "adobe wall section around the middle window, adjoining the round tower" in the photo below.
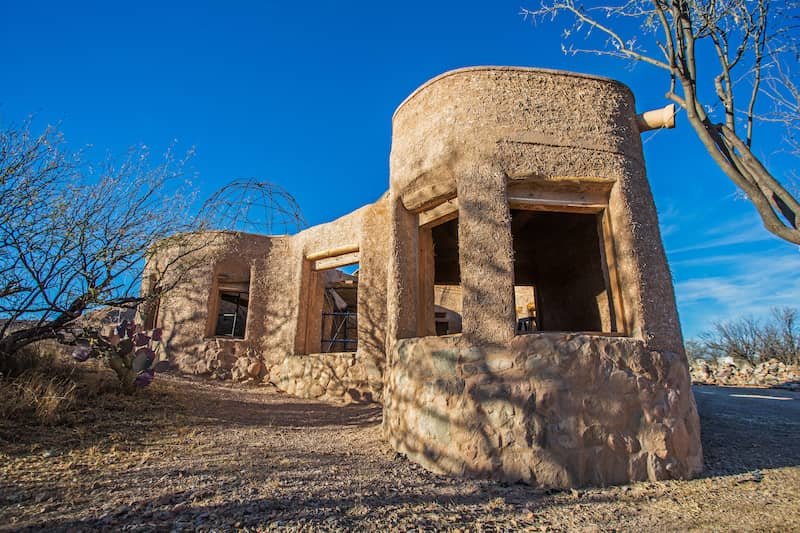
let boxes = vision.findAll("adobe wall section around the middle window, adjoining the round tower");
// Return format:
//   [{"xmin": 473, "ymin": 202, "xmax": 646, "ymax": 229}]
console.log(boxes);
[{"xmin": 271, "ymin": 198, "xmax": 388, "ymax": 401}]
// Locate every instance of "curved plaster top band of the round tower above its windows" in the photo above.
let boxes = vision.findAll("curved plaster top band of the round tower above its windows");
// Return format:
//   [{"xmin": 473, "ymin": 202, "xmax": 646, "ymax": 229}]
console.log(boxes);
[{"xmin": 390, "ymin": 67, "xmax": 643, "ymax": 209}]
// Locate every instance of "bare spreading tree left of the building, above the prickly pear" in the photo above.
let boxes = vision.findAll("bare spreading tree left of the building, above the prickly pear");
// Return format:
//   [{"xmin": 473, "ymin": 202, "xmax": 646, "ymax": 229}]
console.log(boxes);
[{"xmin": 0, "ymin": 122, "xmax": 211, "ymax": 357}]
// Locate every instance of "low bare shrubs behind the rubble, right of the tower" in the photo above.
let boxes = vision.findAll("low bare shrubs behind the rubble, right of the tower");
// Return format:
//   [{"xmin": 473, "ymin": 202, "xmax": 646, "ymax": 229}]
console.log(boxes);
[{"xmin": 686, "ymin": 307, "xmax": 800, "ymax": 365}]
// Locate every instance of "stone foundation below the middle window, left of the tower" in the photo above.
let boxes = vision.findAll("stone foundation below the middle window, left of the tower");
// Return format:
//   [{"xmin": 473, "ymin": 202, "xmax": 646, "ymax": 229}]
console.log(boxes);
[{"xmin": 270, "ymin": 352, "xmax": 372, "ymax": 403}]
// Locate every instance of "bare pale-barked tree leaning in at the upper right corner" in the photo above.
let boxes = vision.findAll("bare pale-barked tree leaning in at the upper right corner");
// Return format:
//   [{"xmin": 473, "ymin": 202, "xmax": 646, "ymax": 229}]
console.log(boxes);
[{"xmin": 522, "ymin": 0, "xmax": 800, "ymax": 244}]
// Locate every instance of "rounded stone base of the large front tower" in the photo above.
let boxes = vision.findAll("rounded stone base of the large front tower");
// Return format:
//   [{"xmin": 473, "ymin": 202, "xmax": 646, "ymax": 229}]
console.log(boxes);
[{"xmin": 384, "ymin": 333, "xmax": 702, "ymax": 488}]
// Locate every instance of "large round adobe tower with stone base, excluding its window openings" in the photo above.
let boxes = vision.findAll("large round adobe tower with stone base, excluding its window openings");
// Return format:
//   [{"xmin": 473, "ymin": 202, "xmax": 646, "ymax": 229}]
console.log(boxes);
[{"xmin": 384, "ymin": 67, "xmax": 702, "ymax": 487}]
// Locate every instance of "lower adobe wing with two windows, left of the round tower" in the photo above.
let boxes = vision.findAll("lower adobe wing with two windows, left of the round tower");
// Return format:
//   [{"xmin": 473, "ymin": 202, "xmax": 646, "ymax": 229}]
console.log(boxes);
[{"xmin": 143, "ymin": 200, "xmax": 388, "ymax": 401}]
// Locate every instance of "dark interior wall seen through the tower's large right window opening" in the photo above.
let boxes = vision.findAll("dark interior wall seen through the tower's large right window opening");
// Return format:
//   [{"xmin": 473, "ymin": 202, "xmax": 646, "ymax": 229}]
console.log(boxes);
[{"xmin": 511, "ymin": 210, "xmax": 610, "ymax": 331}]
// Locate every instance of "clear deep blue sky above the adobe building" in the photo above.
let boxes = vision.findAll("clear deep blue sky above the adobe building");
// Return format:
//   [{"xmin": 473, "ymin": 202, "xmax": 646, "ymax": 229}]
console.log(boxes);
[{"xmin": 0, "ymin": 0, "xmax": 800, "ymax": 337}]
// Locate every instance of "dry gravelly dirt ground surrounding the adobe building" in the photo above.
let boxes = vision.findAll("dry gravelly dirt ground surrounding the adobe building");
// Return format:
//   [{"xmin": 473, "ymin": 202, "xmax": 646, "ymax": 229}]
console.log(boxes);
[{"xmin": 0, "ymin": 368, "xmax": 800, "ymax": 532}]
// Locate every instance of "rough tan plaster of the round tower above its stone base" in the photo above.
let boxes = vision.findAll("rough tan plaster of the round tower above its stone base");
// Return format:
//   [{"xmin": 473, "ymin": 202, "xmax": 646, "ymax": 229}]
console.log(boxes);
[{"xmin": 390, "ymin": 67, "xmax": 683, "ymax": 352}]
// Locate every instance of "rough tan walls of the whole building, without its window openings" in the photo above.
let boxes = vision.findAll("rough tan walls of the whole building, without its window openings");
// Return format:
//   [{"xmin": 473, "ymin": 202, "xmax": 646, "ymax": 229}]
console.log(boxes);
[{"xmin": 145, "ymin": 67, "xmax": 702, "ymax": 487}]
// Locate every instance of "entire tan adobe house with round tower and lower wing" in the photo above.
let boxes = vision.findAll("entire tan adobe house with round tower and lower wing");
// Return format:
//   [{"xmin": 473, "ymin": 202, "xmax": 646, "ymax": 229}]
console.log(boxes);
[{"xmin": 143, "ymin": 67, "xmax": 702, "ymax": 487}]
